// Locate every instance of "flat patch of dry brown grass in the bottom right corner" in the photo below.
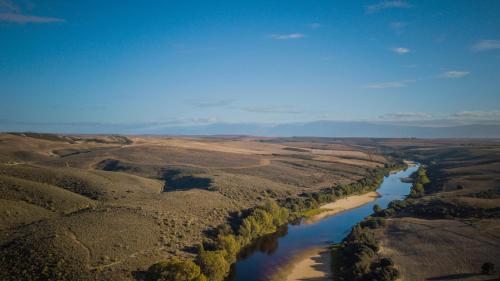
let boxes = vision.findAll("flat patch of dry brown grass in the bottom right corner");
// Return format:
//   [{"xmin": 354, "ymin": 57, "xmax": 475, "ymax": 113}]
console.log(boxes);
[{"xmin": 381, "ymin": 218, "xmax": 500, "ymax": 280}]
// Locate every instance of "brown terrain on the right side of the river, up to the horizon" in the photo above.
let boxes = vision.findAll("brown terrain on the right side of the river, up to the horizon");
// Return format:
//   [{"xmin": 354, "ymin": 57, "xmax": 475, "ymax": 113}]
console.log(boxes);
[{"xmin": 379, "ymin": 140, "xmax": 500, "ymax": 280}]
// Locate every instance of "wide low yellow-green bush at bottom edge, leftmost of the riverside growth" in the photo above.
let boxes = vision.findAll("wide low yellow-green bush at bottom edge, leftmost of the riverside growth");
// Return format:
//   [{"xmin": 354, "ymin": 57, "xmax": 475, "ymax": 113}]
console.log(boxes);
[{"xmin": 146, "ymin": 257, "xmax": 207, "ymax": 281}]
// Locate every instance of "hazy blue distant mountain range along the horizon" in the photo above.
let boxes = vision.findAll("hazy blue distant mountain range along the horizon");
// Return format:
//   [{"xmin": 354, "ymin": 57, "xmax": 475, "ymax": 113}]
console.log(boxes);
[{"xmin": 0, "ymin": 121, "xmax": 500, "ymax": 138}]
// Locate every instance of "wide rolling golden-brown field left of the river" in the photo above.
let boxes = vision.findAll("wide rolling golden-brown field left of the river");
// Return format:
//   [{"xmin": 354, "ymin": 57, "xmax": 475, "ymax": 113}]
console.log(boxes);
[{"xmin": 0, "ymin": 134, "xmax": 387, "ymax": 280}]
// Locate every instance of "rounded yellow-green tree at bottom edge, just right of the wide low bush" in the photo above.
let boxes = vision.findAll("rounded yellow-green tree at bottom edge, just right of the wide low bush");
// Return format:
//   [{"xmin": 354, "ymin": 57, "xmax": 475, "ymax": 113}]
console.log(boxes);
[{"xmin": 197, "ymin": 250, "xmax": 229, "ymax": 281}]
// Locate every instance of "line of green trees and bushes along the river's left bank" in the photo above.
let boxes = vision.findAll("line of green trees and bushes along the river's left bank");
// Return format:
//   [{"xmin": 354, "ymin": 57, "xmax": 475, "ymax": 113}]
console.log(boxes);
[{"xmin": 148, "ymin": 162, "xmax": 403, "ymax": 281}]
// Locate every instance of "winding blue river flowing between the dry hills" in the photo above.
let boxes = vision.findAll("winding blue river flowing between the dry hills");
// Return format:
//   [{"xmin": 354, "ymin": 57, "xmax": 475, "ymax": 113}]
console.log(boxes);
[{"xmin": 228, "ymin": 166, "xmax": 418, "ymax": 281}]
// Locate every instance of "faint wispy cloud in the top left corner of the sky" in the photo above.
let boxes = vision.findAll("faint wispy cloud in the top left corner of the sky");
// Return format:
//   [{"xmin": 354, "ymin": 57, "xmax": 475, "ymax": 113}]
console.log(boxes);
[{"xmin": 0, "ymin": 0, "xmax": 65, "ymax": 24}]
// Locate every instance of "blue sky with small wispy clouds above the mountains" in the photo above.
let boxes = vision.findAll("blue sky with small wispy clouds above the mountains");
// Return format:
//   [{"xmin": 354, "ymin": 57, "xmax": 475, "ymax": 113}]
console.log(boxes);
[{"xmin": 0, "ymin": 0, "xmax": 500, "ymax": 131}]
